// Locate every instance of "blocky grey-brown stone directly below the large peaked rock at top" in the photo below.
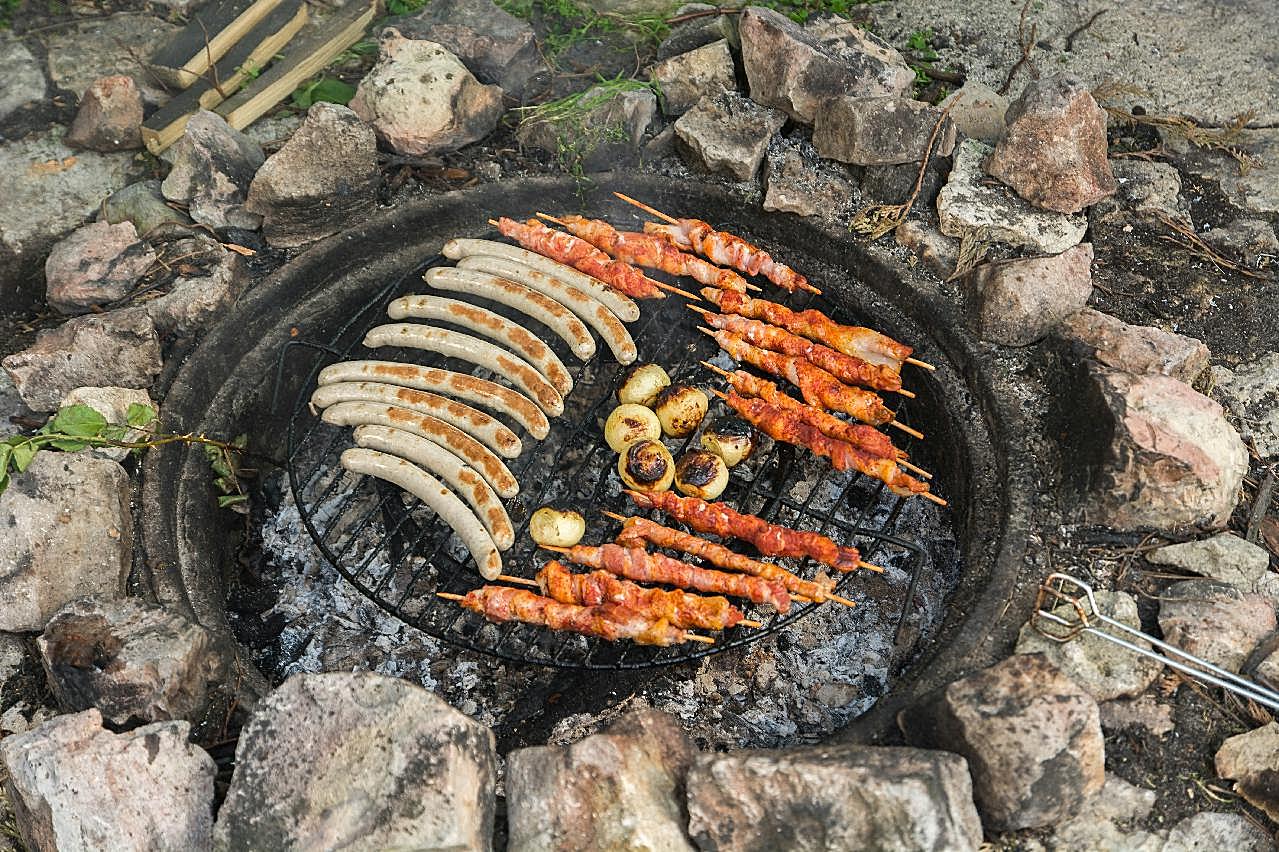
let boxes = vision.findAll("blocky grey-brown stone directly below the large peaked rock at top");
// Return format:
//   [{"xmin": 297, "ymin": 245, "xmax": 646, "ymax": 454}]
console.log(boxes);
[{"xmin": 812, "ymin": 97, "xmax": 955, "ymax": 165}]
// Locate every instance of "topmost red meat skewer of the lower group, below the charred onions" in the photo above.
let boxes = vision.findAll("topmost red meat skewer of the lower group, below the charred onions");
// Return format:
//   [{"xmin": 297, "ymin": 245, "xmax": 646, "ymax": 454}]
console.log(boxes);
[{"xmin": 627, "ymin": 490, "xmax": 883, "ymax": 572}]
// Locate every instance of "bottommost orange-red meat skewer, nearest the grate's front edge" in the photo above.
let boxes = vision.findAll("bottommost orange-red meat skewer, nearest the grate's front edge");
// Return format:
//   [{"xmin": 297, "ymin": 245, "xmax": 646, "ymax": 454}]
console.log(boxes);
[{"xmin": 435, "ymin": 586, "xmax": 715, "ymax": 646}]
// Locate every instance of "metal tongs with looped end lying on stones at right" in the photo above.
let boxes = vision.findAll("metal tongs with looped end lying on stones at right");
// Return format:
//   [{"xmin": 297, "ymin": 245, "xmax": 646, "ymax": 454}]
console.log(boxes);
[{"xmin": 1031, "ymin": 573, "xmax": 1279, "ymax": 711}]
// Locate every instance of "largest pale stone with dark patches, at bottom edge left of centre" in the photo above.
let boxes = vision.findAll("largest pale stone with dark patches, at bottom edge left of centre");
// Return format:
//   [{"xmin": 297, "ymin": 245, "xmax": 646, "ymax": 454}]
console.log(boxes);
[{"xmin": 214, "ymin": 673, "xmax": 496, "ymax": 852}]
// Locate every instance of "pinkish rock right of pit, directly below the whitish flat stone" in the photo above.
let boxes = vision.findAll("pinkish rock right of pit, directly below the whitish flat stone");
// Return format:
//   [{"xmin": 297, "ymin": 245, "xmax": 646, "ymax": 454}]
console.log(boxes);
[{"xmin": 963, "ymin": 243, "xmax": 1092, "ymax": 347}]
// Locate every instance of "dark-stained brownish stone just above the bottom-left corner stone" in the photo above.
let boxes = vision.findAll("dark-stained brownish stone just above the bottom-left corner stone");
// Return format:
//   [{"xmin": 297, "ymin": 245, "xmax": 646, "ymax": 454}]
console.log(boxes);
[{"xmin": 37, "ymin": 597, "xmax": 225, "ymax": 727}]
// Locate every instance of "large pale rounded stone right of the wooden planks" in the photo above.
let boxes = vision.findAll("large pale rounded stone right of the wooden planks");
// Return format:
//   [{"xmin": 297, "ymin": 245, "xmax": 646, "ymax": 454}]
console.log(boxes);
[{"xmin": 350, "ymin": 27, "xmax": 503, "ymax": 155}]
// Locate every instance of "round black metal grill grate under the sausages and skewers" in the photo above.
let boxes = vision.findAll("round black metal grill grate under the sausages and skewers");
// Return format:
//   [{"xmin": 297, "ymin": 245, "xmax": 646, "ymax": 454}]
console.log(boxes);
[{"xmin": 280, "ymin": 235, "xmax": 941, "ymax": 669}]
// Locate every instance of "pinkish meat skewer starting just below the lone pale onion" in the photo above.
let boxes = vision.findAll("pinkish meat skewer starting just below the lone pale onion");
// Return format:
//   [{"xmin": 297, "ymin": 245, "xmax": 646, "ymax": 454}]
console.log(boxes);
[{"xmin": 546, "ymin": 544, "xmax": 790, "ymax": 614}]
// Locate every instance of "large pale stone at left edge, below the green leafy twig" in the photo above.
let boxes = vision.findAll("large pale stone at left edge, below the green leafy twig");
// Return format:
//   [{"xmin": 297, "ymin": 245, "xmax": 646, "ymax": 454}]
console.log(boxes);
[{"xmin": 0, "ymin": 452, "xmax": 133, "ymax": 632}]
